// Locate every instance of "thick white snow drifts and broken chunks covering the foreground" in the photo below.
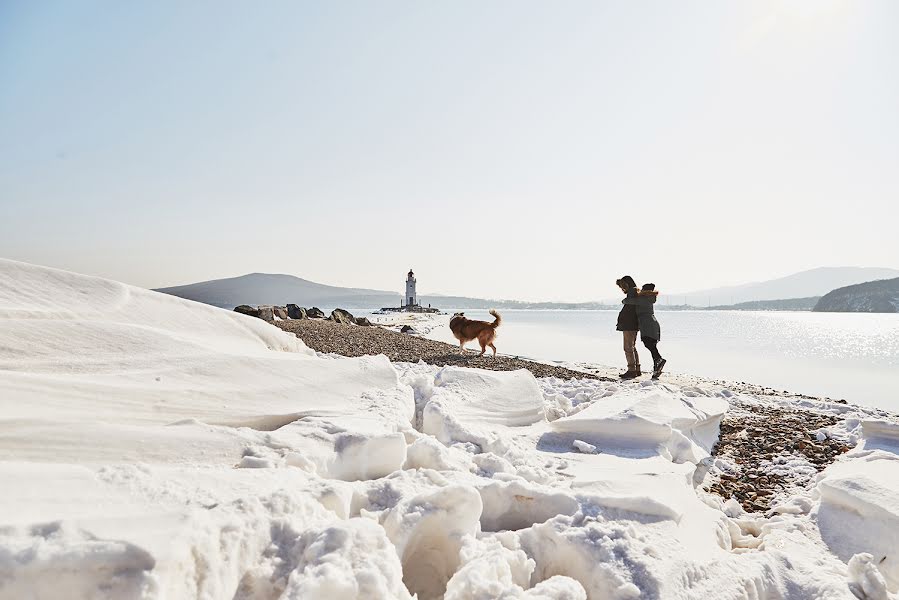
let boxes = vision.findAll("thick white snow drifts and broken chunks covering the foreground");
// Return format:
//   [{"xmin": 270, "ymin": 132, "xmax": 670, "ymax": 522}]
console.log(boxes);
[{"xmin": 0, "ymin": 261, "xmax": 899, "ymax": 600}]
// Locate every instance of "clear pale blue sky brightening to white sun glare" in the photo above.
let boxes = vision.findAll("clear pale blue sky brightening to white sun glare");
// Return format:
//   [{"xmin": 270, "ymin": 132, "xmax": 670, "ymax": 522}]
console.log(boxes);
[{"xmin": 0, "ymin": 0, "xmax": 899, "ymax": 301}]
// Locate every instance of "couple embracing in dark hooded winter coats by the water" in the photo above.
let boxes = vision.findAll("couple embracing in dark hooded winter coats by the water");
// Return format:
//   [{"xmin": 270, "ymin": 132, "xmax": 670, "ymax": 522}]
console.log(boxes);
[{"xmin": 615, "ymin": 275, "xmax": 666, "ymax": 379}]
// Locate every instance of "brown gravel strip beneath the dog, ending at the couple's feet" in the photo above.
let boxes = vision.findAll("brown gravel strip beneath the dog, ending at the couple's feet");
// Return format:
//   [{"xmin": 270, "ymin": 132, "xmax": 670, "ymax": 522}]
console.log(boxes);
[{"xmin": 275, "ymin": 319, "xmax": 617, "ymax": 381}]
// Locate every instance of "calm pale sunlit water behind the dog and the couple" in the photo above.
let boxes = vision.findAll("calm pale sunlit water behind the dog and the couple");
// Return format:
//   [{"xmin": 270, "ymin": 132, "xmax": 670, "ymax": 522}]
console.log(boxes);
[{"xmin": 429, "ymin": 310, "xmax": 899, "ymax": 411}]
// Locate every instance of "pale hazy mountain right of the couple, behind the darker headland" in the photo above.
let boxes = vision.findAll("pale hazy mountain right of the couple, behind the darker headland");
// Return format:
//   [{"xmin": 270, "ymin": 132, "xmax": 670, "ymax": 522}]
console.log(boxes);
[{"xmin": 676, "ymin": 267, "xmax": 899, "ymax": 306}]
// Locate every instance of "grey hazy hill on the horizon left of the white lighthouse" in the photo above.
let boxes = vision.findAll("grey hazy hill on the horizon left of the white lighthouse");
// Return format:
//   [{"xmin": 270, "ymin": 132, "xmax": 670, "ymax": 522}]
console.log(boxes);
[{"xmin": 156, "ymin": 273, "xmax": 402, "ymax": 308}]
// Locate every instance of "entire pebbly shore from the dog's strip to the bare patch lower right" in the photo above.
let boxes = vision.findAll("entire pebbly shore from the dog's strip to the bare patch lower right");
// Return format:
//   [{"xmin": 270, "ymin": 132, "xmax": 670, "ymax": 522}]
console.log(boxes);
[{"xmin": 274, "ymin": 319, "xmax": 899, "ymax": 513}]
